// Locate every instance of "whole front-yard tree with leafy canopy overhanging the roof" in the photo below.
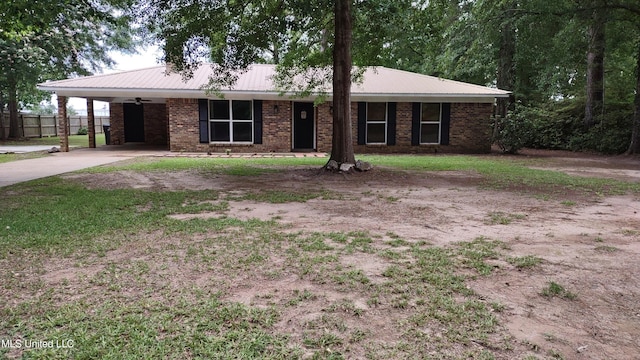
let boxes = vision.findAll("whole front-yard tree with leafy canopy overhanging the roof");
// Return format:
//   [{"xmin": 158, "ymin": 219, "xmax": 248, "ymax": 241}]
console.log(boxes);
[{"xmin": 138, "ymin": 0, "xmax": 410, "ymax": 163}]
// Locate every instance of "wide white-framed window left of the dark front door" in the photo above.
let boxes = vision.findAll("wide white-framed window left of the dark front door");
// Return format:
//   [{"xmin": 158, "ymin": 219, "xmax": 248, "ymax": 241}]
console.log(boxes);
[{"xmin": 209, "ymin": 100, "xmax": 253, "ymax": 143}]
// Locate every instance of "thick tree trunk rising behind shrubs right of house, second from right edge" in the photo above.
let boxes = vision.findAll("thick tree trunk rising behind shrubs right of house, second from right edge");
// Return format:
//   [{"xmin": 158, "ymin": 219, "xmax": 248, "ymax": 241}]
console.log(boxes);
[{"xmin": 583, "ymin": 8, "xmax": 607, "ymax": 128}]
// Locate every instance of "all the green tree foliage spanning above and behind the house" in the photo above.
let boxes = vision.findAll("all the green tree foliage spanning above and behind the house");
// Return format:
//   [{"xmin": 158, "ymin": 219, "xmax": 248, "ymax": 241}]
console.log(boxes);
[{"xmin": 0, "ymin": 0, "xmax": 640, "ymax": 155}]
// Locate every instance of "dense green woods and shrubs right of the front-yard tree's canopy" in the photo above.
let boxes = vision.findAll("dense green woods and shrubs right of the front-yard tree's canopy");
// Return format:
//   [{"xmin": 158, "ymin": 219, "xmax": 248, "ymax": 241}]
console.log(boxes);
[{"xmin": 372, "ymin": 0, "xmax": 640, "ymax": 153}]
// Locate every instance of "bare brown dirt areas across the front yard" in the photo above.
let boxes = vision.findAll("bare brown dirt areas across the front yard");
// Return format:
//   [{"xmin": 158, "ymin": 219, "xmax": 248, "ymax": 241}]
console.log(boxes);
[{"xmin": 46, "ymin": 152, "xmax": 640, "ymax": 359}]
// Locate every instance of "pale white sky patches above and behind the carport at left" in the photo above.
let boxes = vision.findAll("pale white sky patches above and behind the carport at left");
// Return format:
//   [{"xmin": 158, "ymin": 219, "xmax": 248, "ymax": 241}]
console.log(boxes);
[{"xmin": 65, "ymin": 46, "xmax": 161, "ymax": 116}]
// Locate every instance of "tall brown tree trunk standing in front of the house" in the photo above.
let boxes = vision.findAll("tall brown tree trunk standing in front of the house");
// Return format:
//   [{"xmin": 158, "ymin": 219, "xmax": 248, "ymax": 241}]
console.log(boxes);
[{"xmin": 330, "ymin": 0, "xmax": 355, "ymax": 164}]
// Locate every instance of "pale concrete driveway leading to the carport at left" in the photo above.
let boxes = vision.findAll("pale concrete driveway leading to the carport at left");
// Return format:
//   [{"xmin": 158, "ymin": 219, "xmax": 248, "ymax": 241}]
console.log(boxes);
[{"xmin": 0, "ymin": 146, "xmax": 168, "ymax": 187}]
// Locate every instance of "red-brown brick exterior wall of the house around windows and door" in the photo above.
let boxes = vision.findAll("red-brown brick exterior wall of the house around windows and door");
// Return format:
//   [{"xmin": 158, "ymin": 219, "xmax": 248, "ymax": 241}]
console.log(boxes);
[{"xmin": 132, "ymin": 99, "xmax": 493, "ymax": 153}]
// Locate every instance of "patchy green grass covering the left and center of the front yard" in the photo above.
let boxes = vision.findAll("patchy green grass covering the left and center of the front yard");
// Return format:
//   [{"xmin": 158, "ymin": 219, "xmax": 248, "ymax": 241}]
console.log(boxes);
[{"xmin": 0, "ymin": 178, "xmax": 516, "ymax": 359}]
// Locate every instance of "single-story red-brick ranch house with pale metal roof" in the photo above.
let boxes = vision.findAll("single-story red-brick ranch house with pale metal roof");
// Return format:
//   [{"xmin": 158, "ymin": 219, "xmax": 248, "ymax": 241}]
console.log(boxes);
[{"xmin": 39, "ymin": 65, "xmax": 509, "ymax": 153}]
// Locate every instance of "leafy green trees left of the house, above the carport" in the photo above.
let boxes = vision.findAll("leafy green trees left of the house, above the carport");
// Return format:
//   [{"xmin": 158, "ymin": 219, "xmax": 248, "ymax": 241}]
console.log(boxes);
[{"xmin": 0, "ymin": 0, "xmax": 134, "ymax": 137}]
